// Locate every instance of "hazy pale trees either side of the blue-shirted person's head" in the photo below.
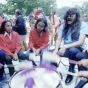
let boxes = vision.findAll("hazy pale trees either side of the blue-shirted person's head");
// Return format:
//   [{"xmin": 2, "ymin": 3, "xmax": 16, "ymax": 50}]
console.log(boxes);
[{"xmin": 57, "ymin": 1, "xmax": 88, "ymax": 22}]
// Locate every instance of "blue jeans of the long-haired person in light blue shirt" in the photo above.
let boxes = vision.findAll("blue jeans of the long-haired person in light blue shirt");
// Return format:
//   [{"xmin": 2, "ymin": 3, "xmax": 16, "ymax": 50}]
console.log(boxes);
[{"xmin": 49, "ymin": 47, "xmax": 83, "ymax": 72}]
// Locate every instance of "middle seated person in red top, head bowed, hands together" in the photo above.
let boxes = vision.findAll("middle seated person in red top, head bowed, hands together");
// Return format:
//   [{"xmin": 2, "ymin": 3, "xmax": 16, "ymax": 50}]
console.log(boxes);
[{"xmin": 26, "ymin": 18, "xmax": 50, "ymax": 63}]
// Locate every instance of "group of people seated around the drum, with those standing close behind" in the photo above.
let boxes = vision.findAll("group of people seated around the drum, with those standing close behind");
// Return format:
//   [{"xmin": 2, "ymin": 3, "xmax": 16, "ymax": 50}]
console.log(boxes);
[{"xmin": 0, "ymin": 8, "xmax": 88, "ymax": 88}]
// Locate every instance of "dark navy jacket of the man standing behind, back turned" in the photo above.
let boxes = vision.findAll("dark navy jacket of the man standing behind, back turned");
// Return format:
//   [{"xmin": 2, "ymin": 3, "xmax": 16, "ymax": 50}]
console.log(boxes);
[{"xmin": 13, "ymin": 15, "xmax": 27, "ymax": 35}]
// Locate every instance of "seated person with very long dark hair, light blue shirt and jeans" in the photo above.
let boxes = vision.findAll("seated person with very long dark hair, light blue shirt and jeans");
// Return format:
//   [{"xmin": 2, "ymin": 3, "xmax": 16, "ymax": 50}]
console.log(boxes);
[{"xmin": 45, "ymin": 8, "xmax": 88, "ymax": 84}]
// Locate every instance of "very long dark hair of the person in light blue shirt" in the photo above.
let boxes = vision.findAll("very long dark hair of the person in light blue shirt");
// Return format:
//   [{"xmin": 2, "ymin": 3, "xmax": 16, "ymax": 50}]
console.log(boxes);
[{"xmin": 63, "ymin": 8, "xmax": 81, "ymax": 37}]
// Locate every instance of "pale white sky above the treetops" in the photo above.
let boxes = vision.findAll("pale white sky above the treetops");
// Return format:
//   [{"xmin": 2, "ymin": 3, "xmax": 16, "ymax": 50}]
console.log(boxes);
[{"xmin": 0, "ymin": 0, "xmax": 88, "ymax": 8}]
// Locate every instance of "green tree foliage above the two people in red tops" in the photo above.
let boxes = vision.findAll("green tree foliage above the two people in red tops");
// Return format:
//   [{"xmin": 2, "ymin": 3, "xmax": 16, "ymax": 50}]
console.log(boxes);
[{"xmin": 3, "ymin": 0, "xmax": 56, "ymax": 15}]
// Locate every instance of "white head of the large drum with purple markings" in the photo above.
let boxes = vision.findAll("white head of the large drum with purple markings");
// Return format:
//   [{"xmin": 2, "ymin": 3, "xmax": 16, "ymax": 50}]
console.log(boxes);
[{"xmin": 9, "ymin": 68, "xmax": 63, "ymax": 88}]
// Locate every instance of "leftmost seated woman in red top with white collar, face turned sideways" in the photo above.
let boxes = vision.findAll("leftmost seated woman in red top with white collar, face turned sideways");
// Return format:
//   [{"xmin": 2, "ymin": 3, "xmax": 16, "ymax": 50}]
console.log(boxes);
[{"xmin": 0, "ymin": 20, "xmax": 25, "ymax": 76}]
